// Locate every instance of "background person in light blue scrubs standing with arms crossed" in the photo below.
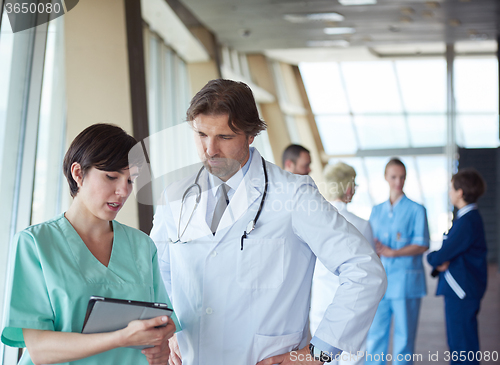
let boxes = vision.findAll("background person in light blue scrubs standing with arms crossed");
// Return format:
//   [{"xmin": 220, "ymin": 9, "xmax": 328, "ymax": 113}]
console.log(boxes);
[{"xmin": 366, "ymin": 158, "xmax": 429, "ymax": 365}]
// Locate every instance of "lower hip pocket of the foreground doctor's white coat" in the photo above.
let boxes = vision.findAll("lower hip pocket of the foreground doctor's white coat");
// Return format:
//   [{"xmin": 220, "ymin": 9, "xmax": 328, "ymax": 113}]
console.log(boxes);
[{"xmin": 253, "ymin": 331, "xmax": 302, "ymax": 362}]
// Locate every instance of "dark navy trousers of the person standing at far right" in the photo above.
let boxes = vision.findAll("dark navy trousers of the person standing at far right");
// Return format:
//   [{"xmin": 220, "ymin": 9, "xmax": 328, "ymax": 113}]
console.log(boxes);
[{"xmin": 444, "ymin": 296, "xmax": 481, "ymax": 364}]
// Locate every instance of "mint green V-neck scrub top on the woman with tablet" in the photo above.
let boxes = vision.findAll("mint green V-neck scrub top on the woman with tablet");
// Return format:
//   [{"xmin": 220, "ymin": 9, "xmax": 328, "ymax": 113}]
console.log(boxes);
[{"xmin": 1, "ymin": 214, "xmax": 180, "ymax": 365}]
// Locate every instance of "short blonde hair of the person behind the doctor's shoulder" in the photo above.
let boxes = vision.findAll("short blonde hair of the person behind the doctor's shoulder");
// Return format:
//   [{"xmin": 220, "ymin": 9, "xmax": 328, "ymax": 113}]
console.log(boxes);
[{"xmin": 323, "ymin": 162, "xmax": 356, "ymax": 200}]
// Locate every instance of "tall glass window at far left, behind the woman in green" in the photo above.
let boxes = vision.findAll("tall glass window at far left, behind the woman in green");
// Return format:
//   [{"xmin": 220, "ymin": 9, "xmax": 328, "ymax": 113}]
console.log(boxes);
[{"xmin": 0, "ymin": 12, "xmax": 65, "ymax": 365}]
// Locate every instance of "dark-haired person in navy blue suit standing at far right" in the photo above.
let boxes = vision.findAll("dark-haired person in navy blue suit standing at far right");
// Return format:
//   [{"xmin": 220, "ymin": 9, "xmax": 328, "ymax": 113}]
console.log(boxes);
[{"xmin": 427, "ymin": 169, "xmax": 488, "ymax": 364}]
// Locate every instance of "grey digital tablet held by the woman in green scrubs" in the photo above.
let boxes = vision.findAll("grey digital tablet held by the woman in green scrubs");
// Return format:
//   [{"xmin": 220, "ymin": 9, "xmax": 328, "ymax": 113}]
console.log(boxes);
[{"xmin": 82, "ymin": 296, "xmax": 173, "ymax": 349}]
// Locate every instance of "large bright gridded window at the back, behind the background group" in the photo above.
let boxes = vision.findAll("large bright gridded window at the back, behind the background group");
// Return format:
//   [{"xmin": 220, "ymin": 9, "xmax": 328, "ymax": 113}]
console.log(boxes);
[{"xmin": 299, "ymin": 57, "xmax": 500, "ymax": 241}]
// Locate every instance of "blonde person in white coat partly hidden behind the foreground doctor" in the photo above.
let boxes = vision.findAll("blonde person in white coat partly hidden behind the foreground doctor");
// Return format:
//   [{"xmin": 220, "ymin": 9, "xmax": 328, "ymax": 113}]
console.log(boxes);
[{"xmin": 309, "ymin": 162, "xmax": 374, "ymax": 364}]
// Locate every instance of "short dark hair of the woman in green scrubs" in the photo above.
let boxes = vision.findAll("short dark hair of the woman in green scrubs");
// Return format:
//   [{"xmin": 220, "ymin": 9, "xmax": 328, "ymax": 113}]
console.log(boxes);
[{"xmin": 63, "ymin": 124, "xmax": 142, "ymax": 197}]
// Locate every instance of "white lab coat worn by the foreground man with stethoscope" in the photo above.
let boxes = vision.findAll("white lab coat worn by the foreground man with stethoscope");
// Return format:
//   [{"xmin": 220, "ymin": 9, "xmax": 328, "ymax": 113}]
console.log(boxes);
[{"xmin": 151, "ymin": 150, "xmax": 386, "ymax": 365}]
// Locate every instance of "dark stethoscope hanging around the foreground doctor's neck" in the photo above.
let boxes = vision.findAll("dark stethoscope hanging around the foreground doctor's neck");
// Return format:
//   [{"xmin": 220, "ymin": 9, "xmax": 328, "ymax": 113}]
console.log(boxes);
[{"xmin": 171, "ymin": 157, "xmax": 268, "ymax": 250}]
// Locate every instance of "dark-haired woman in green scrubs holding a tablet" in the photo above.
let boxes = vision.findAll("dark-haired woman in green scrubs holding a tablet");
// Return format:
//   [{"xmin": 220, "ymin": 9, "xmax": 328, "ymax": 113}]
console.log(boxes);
[{"xmin": 2, "ymin": 124, "xmax": 176, "ymax": 365}]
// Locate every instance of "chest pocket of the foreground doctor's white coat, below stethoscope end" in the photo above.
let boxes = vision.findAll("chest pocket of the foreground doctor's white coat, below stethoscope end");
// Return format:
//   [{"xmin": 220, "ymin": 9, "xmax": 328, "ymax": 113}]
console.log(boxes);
[{"xmin": 237, "ymin": 238, "xmax": 285, "ymax": 289}]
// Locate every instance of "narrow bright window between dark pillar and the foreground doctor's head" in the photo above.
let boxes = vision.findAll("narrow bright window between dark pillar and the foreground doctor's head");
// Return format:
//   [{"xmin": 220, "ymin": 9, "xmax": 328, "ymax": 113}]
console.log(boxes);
[{"xmin": 145, "ymin": 28, "xmax": 199, "ymax": 202}]
